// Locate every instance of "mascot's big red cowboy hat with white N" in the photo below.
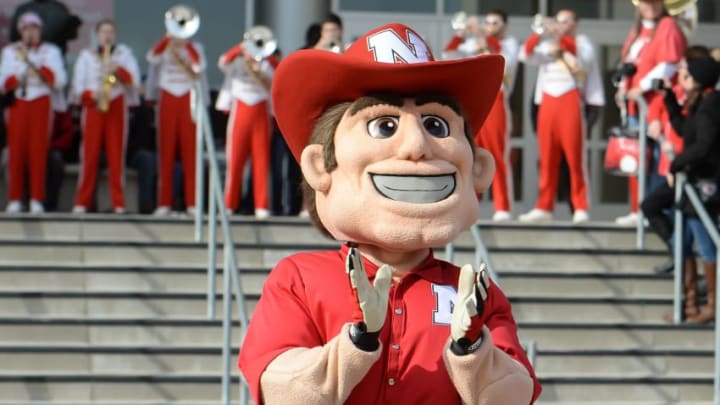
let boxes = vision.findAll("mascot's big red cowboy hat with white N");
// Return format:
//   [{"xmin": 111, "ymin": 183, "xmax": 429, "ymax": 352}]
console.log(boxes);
[{"xmin": 272, "ymin": 23, "xmax": 504, "ymax": 161}]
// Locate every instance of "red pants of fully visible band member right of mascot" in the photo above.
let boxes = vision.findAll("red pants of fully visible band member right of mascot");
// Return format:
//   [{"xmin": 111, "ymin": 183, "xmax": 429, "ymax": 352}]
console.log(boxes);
[{"xmin": 535, "ymin": 89, "xmax": 588, "ymax": 211}]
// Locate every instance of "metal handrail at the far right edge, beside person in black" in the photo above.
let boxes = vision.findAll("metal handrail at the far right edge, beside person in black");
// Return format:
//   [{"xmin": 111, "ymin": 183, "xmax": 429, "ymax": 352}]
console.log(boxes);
[{"xmin": 673, "ymin": 173, "xmax": 720, "ymax": 405}]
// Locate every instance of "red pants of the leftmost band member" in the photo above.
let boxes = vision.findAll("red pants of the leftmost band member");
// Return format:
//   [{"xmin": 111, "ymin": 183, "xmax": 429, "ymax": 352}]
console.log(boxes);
[{"xmin": 6, "ymin": 96, "xmax": 52, "ymax": 202}]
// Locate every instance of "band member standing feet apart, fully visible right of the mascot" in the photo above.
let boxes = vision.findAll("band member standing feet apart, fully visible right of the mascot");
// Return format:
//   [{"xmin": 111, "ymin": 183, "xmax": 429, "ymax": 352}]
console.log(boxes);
[{"xmin": 519, "ymin": 10, "xmax": 605, "ymax": 223}]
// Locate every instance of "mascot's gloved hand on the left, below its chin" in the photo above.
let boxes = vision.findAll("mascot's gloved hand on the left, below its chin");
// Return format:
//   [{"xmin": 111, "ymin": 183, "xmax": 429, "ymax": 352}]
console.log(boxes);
[{"xmin": 345, "ymin": 247, "xmax": 392, "ymax": 352}]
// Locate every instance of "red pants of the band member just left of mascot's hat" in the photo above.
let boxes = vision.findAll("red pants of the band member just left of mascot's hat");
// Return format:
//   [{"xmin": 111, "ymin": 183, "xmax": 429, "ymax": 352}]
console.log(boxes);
[{"xmin": 225, "ymin": 100, "xmax": 270, "ymax": 210}]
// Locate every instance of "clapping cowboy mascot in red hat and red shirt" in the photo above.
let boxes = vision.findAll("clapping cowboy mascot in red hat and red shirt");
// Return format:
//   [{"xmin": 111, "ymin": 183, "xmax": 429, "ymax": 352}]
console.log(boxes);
[{"xmin": 239, "ymin": 24, "xmax": 540, "ymax": 405}]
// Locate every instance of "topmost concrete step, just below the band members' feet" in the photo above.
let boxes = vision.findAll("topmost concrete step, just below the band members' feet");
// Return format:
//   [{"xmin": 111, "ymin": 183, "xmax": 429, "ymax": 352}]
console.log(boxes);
[{"xmin": 0, "ymin": 214, "xmax": 663, "ymax": 249}]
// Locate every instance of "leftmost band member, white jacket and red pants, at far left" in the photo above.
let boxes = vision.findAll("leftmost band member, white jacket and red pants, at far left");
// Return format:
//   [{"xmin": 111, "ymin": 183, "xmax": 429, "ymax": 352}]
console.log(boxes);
[{"xmin": 0, "ymin": 12, "xmax": 67, "ymax": 213}]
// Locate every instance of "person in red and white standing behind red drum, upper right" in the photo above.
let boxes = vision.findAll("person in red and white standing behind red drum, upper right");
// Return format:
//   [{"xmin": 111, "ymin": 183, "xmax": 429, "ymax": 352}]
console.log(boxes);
[{"xmin": 615, "ymin": 0, "xmax": 687, "ymax": 225}]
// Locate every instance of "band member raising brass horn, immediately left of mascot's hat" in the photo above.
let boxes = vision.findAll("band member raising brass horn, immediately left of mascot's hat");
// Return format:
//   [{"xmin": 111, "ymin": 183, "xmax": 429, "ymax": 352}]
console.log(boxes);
[{"xmin": 216, "ymin": 27, "xmax": 277, "ymax": 218}]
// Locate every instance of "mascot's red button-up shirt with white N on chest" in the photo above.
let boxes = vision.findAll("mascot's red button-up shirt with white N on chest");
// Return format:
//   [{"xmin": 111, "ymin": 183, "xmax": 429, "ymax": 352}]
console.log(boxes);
[{"xmin": 239, "ymin": 246, "xmax": 540, "ymax": 405}]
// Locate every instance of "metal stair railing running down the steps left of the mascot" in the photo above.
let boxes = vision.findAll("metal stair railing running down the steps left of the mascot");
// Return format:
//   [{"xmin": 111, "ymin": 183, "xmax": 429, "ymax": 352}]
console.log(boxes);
[{"xmin": 191, "ymin": 81, "xmax": 249, "ymax": 405}]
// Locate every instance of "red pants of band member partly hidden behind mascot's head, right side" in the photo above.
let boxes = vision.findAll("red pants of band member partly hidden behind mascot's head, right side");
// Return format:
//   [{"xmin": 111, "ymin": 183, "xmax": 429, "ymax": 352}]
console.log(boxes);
[{"xmin": 475, "ymin": 91, "xmax": 512, "ymax": 212}]
